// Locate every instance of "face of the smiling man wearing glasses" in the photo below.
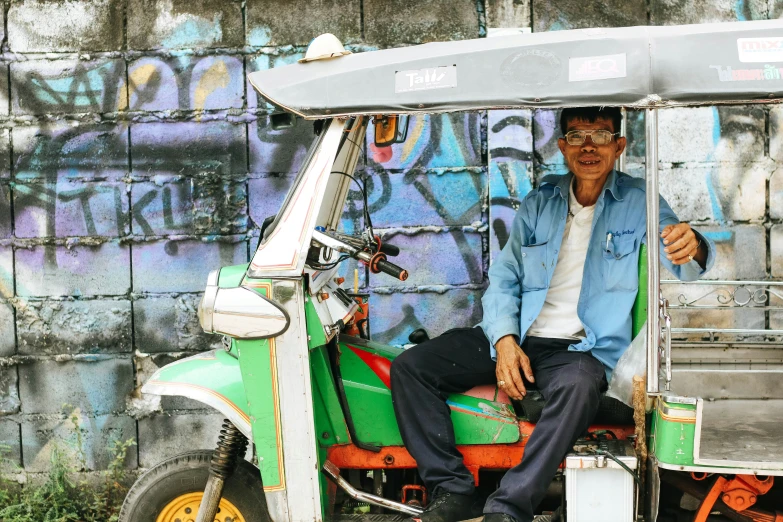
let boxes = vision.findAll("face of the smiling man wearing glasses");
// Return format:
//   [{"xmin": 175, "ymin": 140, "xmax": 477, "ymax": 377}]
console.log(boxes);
[{"xmin": 557, "ymin": 118, "xmax": 625, "ymax": 182}]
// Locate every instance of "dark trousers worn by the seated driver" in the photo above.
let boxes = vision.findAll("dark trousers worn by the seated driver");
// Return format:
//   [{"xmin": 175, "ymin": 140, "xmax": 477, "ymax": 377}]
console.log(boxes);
[{"xmin": 391, "ymin": 327, "xmax": 606, "ymax": 522}]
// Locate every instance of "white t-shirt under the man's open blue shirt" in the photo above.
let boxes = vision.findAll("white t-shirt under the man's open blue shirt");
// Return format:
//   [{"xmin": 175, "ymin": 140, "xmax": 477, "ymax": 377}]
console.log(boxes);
[{"xmin": 527, "ymin": 181, "xmax": 595, "ymax": 340}]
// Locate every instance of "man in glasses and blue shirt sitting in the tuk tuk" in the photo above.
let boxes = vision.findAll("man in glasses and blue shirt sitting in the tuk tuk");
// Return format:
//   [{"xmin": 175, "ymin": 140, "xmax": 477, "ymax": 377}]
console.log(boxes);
[{"xmin": 391, "ymin": 107, "xmax": 714, "ymax": 522}]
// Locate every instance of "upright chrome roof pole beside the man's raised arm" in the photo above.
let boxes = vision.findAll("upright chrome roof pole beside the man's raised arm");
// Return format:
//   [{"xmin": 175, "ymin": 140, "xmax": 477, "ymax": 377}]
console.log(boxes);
[{"xmin": 644, "ymin": 109, "xmax": 661, "ymax": 395}]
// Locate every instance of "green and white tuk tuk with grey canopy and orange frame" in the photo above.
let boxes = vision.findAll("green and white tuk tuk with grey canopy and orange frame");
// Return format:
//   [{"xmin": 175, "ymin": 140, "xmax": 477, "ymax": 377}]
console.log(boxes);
[{"xmin": 120, "ymin": 21, "xmax": 783, "ymax": 522}]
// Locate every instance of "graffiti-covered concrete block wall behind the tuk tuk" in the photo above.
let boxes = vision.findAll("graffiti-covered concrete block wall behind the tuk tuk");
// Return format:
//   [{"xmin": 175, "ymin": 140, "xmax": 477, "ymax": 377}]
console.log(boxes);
[{"xmin": 0, "ymin": 0, "xmax": 783, "ymax": 473}]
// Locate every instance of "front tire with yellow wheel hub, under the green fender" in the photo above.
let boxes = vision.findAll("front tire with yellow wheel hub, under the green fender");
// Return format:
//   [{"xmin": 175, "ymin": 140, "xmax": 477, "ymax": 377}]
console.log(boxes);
[{"xmin": 119, "ymin": 450, "xmax": 271, "ymax": 522}]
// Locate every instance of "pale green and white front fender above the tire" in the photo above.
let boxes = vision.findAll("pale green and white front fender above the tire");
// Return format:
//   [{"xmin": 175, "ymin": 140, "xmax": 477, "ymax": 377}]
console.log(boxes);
[{"xmin": 141, "ymin": 350, "xmax": 253, "ymax": 440}]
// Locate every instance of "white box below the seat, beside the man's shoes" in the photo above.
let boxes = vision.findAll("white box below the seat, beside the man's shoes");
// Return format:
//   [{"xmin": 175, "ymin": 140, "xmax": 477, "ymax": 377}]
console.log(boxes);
[{"xmin": 565, "ymin": 441, "xmax": 637, "ymax": 522}]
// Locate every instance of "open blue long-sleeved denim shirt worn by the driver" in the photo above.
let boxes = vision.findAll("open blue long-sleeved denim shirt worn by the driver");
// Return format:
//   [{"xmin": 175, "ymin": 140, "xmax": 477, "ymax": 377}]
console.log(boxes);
[{"xmin": 479, "ymin": 170, "xmax": 715, "ymax": 378}]
